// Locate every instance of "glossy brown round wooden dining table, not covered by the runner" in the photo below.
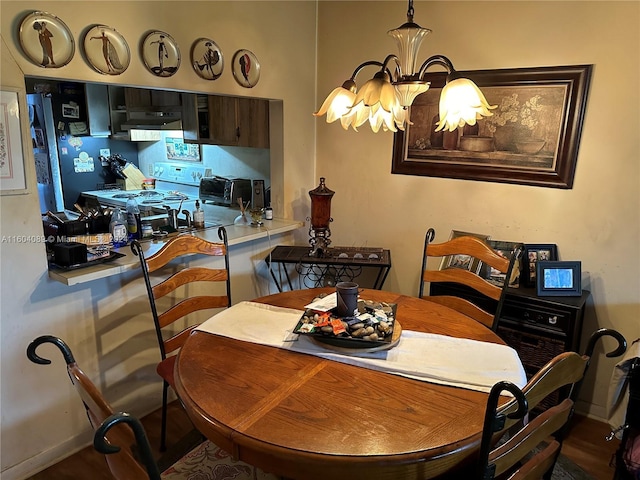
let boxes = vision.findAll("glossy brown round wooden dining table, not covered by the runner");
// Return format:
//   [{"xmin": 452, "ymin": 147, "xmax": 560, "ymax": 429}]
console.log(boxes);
[{"xmin": 175, "ymin": 288, "xmax": 504, "ymax": 480}]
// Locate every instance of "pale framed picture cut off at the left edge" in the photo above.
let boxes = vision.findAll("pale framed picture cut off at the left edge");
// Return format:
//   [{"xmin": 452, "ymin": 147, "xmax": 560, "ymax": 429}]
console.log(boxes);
[{"xmin": 0, "ymin": 87, "xmax": 29, "ymax": 195}]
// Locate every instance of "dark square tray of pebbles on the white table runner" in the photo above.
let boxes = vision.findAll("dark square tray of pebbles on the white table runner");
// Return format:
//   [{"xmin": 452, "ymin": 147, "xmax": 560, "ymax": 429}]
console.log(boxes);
[{"xmin": 293, "ymin": 300, "xmax": 402, "ymax": 351}]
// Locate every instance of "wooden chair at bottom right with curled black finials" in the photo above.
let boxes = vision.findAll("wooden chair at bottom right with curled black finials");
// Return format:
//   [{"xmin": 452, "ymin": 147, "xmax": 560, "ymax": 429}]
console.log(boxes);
[{"xmin": 475, "ymin": 329, "xmax": 626, "ymax": 480}]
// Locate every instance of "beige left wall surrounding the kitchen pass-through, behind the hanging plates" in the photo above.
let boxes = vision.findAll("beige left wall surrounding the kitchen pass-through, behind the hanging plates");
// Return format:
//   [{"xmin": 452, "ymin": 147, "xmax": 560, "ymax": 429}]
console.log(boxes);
[{"xmin": 0, "ymin": 1, "xmax": 316, "ymax": 480}]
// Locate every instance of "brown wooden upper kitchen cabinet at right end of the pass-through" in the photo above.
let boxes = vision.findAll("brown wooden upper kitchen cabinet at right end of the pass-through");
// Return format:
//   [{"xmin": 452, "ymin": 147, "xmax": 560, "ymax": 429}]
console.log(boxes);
[{"xmin": 183, "ymin": 95, "xmax": 269, "ymax": 148}]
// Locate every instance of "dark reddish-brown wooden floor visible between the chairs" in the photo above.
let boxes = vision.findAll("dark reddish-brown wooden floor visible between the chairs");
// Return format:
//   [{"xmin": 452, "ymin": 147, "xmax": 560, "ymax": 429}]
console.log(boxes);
[{"xmin": 29, "ymin": 402, "xmax": 618, "ymax": 480}]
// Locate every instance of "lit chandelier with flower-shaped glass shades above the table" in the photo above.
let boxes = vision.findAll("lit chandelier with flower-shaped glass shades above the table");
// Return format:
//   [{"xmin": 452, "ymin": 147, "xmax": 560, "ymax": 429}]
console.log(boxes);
[{"xmin": 314, "ymin": 0, "xmax": 496, "ymax": 132}]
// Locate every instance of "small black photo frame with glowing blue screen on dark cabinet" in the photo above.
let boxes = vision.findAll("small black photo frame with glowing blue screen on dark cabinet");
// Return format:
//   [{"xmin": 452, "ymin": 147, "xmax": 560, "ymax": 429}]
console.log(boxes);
[{"xmin": 536, "ymin": 260, "xmax": 582, "ymax": 297}]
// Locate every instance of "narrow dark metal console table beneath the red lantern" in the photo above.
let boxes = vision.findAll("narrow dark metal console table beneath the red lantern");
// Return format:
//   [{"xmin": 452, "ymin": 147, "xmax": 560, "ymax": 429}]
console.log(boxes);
[{"xmin": 265, "ymin": 245, "xmax": 391, "ymax": 292}]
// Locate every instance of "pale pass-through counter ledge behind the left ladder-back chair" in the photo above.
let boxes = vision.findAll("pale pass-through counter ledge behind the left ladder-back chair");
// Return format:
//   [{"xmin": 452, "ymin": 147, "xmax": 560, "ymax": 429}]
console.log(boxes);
[{"xmin": 49, "ymin": 218, "xmax": 304, "ymax": 285}]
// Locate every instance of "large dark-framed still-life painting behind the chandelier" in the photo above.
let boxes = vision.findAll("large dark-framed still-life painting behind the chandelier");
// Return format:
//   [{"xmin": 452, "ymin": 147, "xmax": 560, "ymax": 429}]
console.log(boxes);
[{"xmin": 391, "ymin": 65, "xmax": 593, "ymax": 188}]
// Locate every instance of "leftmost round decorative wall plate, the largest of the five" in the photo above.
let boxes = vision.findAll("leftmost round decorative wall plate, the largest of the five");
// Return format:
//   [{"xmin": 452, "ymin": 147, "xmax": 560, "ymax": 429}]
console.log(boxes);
[{"xmin": 18, "ymin": 12, "xmax": 76, "ymax": 68}]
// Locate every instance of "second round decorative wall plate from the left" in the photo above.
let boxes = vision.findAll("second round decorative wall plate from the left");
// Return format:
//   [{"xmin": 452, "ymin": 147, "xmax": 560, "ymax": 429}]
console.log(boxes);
[{"xmin": 84, "ymin": 25, "xmax": 131, "ymax": 75}]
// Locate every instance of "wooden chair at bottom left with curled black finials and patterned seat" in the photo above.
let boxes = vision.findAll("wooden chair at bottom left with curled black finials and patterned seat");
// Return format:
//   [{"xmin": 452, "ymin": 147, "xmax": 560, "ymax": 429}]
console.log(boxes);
[{"xmin": 27, "ymin": 335, "xmax": 278, "ymax": 480}]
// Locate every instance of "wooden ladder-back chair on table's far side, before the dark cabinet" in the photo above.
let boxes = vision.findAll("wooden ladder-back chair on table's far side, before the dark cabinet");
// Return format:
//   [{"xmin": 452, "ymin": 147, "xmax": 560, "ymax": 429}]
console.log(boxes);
[{"xmin": 418, "ymin": 228, "xmax": 523, "ymax": 331}]
